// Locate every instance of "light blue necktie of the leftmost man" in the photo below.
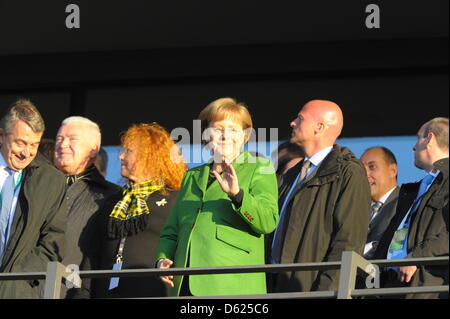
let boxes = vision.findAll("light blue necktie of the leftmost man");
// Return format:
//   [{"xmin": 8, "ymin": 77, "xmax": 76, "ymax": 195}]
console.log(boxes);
[{"xmin": 0, "ymin": 168, "xmax": 14, "ymax": 264}]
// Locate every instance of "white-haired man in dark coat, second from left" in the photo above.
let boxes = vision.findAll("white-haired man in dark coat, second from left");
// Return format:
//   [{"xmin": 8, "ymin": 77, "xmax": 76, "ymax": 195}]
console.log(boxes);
[{"xmin": 54, "ymin": 116, "xmax": 120, "ymax": 297}]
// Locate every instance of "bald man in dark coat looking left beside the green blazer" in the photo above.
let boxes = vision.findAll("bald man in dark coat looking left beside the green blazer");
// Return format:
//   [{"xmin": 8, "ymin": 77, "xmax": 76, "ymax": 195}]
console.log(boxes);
[{"xmin": 268, "ymin": 100, "xmax": 371, "ymax": 292}]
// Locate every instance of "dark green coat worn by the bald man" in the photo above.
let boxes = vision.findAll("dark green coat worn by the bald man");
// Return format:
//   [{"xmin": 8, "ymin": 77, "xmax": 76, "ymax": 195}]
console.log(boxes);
[{"xmin": 270, "ymin": 145, "xmax": 371, "ymax": 292}]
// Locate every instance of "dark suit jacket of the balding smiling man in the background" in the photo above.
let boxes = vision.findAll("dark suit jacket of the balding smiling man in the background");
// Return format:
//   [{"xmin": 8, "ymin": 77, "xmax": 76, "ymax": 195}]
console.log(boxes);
[{"xmin": 366, "ymin": 186, "xmax": 400, "ymax": 258}]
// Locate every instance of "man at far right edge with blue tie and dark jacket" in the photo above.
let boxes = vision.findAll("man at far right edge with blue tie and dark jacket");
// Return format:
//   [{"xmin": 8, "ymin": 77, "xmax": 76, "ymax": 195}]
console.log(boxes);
[{"xmin": 374, "ymin": 118, "xmax": 449, "ymax": 298}]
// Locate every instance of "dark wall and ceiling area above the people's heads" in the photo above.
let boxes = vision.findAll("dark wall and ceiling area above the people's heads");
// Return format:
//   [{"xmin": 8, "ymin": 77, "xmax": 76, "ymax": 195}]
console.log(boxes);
[{"xmin": 0, "ymin": 0, "xmax": 449, "ymax": 145}]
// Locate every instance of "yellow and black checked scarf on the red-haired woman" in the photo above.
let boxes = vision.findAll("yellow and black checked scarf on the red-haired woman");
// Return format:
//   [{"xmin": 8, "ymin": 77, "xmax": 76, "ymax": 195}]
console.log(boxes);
[{"xmin": 109, "ymin": 181, "xmax": 164, "ymax": 220}]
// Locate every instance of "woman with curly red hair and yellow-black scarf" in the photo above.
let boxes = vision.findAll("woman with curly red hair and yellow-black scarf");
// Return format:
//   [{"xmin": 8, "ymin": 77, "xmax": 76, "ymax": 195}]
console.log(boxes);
[{"xmin": 69, "ymin": 123, "xmax": 187, "ymax": 298}]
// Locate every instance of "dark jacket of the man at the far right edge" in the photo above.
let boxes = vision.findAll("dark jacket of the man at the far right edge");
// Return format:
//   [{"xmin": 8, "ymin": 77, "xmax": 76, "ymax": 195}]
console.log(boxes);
[{"xmin": 374, "ymin": 157, "xmax": 449, "ymax": 298}]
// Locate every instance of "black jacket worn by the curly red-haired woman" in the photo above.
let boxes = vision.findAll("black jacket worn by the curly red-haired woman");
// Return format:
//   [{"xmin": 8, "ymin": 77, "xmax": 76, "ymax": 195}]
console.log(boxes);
[{"xmin": 68, "ymin": 191, "xmax": 178, "ymax": 298}]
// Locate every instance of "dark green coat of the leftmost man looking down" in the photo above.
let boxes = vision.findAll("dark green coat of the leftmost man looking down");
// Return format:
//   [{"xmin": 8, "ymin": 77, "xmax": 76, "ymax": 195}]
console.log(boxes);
[{"xmin": 0, "ymin": 155, "xmax": 67, "ymax": 299}]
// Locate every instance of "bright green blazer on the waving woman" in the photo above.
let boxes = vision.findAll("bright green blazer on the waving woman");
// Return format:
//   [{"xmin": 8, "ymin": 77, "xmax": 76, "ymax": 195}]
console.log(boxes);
[{"xmin": 157, "ymin": 152, "xmax": 278, "ymax": 296}]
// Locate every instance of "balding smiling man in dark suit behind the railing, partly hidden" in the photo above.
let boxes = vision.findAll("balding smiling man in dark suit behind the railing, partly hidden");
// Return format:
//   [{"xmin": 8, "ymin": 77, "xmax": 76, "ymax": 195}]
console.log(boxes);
[{"xmin": 361, "ymin": 146, "xmax": 400, "ymax": 259}]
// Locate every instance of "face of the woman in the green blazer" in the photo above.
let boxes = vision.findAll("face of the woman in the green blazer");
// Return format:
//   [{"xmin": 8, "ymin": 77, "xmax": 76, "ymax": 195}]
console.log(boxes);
[{"xmin": 209, "ymin": 120, "xmax": 245, "ymax": 162}]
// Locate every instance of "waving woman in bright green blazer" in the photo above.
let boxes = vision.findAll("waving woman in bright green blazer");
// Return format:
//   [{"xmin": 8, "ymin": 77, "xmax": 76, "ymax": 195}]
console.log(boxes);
[{"xmin": 157, "ymin": 98, "xmax": 278, "ymax": 296}]
